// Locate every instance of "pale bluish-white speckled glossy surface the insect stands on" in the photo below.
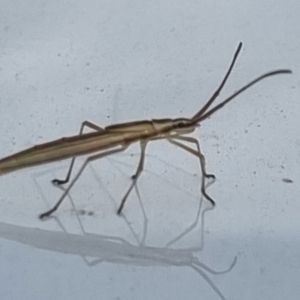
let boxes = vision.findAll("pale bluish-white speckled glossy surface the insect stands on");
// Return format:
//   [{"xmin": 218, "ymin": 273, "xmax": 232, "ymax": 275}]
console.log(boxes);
[{"xmin": 0, "ymin": 1, "xmax": 300, "ymax": 300}]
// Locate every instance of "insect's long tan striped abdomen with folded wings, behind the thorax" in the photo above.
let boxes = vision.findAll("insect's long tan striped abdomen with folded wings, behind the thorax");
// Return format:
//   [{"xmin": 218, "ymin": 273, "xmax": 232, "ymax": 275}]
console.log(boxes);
[{"xmin": 0, "ymin": 119, "xmax": 175, "ymax": 175}]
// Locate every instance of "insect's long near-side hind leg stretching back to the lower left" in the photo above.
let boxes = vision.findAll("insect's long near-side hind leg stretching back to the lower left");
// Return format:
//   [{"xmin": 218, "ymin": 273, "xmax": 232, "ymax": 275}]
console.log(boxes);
[{"xmin": 39, "ymin": 145, "xmax": 128, "ymax": 219}]
